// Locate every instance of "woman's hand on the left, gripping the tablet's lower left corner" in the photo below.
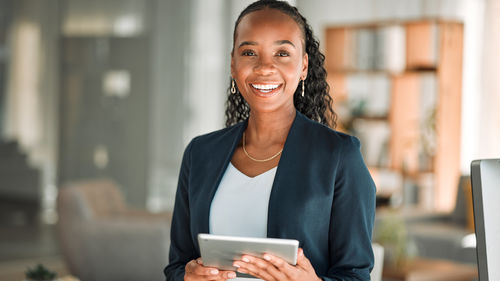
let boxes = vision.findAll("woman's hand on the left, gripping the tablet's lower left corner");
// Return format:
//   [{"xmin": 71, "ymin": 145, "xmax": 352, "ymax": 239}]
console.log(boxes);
[{"xmin": 184, "ymin": 258, "xmax": 236, "ymax": 281}]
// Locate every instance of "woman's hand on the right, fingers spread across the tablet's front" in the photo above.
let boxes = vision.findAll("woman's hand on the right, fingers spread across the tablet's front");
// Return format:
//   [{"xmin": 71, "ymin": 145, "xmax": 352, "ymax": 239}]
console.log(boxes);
[{"xmin": 233, "ymin": 248, "xmax": 321, "ymax": 281}]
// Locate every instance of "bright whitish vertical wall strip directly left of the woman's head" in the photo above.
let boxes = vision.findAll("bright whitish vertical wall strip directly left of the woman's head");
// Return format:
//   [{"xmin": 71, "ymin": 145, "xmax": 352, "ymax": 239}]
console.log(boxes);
[{"xmin": 184, "ymin": 0, "xmax": 229, "ymax": 140}]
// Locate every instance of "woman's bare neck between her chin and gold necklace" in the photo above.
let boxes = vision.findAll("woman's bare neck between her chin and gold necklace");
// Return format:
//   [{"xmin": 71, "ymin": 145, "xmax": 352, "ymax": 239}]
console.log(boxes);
[{"xmin": 246, "ymin": 108, "xmax": 296, "ymax": 147}]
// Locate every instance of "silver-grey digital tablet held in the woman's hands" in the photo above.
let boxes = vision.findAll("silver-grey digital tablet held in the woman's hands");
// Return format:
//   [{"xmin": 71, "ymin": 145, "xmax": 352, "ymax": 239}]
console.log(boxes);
[{"xmin": 198, "ymin": 233, "xmax": 299, "ymax": 271}]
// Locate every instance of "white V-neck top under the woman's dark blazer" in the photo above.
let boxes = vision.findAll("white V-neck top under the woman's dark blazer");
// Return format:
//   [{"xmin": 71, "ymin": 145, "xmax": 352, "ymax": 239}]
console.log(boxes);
[{"xmin": 209, "ymin": 162, "xmax": 277, "ymax": 281}]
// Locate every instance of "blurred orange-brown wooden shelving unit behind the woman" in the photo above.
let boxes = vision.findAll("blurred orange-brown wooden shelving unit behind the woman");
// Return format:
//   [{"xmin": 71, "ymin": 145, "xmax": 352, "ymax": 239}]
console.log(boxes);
[{"xmin": 325, "ymin": 19, "xmax": 463, "ymax": 211}]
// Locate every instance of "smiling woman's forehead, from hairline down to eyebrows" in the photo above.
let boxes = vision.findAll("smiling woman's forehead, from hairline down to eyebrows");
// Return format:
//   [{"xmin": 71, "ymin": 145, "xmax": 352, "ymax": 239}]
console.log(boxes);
[{"xmin": 235, "ymin": 9, "xmax": 303, "ymax": 43}]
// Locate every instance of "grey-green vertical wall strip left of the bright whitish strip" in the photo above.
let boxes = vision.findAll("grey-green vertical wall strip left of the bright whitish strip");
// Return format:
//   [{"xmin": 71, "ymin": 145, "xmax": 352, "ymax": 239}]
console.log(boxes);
[{"xmin": 147, "ymin": 0, "xmax": 196, "ymax": 211}]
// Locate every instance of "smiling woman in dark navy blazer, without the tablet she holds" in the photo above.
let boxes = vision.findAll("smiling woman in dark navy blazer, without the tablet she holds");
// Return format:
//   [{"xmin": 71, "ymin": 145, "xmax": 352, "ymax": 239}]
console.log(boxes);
[{"xmin": 164, "ymin": 1, "xmax": 375, "ymax": 280}]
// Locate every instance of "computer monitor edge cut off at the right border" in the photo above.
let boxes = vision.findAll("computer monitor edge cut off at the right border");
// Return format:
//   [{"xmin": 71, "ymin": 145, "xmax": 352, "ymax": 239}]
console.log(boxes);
[{"xmin": 471, "ymin": 159, "xmax": 500, "ymax": 281}]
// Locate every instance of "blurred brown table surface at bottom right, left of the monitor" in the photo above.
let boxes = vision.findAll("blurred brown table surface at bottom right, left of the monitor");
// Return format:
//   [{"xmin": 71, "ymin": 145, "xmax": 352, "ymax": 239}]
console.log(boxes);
[{"xmin": 382, "ymin": 258, "xmax": 478, "ymax": 281}]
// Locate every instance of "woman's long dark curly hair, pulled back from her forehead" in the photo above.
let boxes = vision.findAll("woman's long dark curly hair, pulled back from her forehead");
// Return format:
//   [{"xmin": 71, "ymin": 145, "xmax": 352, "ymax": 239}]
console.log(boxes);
[{"xmin": 226, "ymin": 0, "xmax": 337, "ymax": 128}]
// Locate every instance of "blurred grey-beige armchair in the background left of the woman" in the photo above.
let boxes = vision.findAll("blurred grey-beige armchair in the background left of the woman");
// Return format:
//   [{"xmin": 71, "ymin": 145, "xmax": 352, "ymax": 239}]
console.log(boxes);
[{"xmin": 57, "ymin": 179, "xmax": 171, "ymax": 281}]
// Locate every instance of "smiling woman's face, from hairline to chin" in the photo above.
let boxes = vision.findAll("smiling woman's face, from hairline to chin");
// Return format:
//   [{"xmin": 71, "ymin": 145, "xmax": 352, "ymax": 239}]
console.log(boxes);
[{"xmin": 231, "ymin": 9, "xmax": 308, "ymax": 112}]
